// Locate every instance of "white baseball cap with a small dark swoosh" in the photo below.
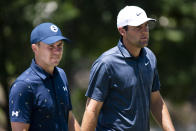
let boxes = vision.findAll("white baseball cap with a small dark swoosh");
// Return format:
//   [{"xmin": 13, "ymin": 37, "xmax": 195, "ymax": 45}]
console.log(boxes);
[{"xmin": 117, "ymin": 6, "xmax": 156, "ymax": 28}]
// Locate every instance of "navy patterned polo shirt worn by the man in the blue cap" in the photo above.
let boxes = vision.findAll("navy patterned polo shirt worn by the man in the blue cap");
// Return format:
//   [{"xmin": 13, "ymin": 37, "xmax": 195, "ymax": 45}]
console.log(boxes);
[{"xmin": 9, "ymin": 60, "xmax": 72, "ymax": 131}]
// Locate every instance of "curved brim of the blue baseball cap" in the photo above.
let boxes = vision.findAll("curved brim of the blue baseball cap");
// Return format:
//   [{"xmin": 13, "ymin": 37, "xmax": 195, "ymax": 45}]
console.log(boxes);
[{"xmin": 41, "ymin": 36, "xmax": 70, "ymax": 45}]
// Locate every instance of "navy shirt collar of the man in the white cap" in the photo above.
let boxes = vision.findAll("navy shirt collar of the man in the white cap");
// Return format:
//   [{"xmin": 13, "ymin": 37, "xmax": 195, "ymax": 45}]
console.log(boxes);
[{"xmin": 118, "ymin": 39, "xmax": 146, "ymax": 58}]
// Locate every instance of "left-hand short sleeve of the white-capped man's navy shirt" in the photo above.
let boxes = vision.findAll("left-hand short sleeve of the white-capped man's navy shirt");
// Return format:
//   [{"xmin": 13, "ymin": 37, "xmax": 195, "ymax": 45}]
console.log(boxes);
[{"xmin": 86, "ymin": 61, "xmax": 111, "ymax": 102}]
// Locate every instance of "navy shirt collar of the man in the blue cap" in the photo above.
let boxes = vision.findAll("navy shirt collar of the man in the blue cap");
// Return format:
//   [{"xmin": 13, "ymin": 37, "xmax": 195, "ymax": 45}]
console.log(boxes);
[{"xmin": 31, "ymin": 59, "xmax": 57, "ymax": 80}]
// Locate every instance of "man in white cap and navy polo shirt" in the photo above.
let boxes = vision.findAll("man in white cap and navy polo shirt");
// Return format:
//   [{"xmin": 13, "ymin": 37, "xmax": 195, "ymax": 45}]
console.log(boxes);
[{"xmin": 81, "ymin": 6, "xmax": 175, "ymax": 131}]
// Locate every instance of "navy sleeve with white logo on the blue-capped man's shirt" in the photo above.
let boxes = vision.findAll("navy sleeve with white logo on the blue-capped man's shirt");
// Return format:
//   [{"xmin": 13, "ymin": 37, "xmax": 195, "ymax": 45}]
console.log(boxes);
[{"xmin": 9, "ymin": 81, "xmax": 33, "ymax": 123}]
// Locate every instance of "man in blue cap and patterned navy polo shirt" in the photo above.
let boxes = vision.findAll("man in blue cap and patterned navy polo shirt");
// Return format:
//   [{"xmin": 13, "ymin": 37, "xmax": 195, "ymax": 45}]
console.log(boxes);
[{"xmin": 9, "ymin": 23, "xmax": 80, "ymax": 131}]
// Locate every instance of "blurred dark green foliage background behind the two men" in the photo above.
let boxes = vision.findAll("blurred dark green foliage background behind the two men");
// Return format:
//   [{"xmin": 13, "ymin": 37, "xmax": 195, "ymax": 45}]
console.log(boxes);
[{"xmin": 0, "ymin": 0, "xmax": 196, "ymax": 131}]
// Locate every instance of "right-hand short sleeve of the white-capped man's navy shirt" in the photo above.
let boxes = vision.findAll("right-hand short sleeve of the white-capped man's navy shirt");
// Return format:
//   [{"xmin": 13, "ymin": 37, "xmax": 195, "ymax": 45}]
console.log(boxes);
[{"xmin": 152, "ymin": 68, "xmax": 161, "ymax": 92}]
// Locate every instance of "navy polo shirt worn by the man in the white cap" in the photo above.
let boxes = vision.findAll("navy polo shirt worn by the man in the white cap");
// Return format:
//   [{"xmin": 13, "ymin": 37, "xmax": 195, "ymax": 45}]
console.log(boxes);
[{"xmin": 86, "ymin": 40, "xmax": 160, "ymax": 131}]
